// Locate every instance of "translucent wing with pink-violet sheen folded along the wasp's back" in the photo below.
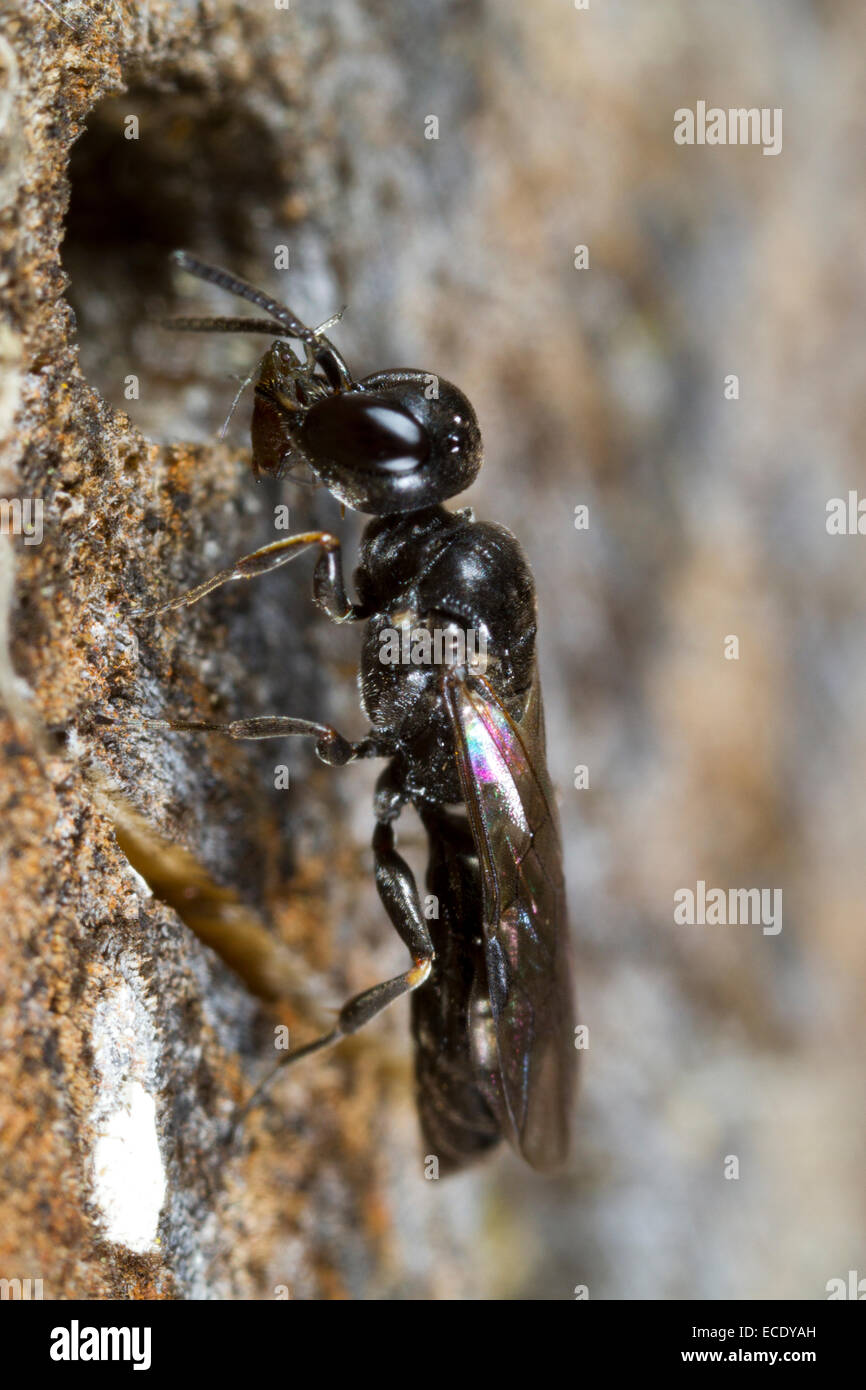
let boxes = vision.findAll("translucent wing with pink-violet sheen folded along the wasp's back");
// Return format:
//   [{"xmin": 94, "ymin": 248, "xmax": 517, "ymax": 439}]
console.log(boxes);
[{"xmin": 445, "ymin": 676, "xmax": 577, "ymax": 1169}]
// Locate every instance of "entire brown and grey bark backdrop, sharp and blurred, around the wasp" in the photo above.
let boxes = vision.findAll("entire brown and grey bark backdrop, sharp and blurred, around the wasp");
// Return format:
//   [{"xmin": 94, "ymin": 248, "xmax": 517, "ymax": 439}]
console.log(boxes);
[{"xmin": 0, "ymin": 0, "xmax": 866, "ymax": 1298}]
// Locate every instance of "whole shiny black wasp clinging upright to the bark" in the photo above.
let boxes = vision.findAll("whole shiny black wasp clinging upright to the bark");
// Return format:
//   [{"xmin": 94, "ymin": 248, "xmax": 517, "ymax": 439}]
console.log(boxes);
[{"xmin": 135, "ymin": 252, "xmax": 577, "ymax": 1172}]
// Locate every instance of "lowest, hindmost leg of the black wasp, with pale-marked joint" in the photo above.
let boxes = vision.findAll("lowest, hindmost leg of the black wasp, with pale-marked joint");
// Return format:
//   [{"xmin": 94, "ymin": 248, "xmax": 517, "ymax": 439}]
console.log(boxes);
[{"xmin": 234, "ymin": 821, "xmax": 434, "ymax": 1130}]
